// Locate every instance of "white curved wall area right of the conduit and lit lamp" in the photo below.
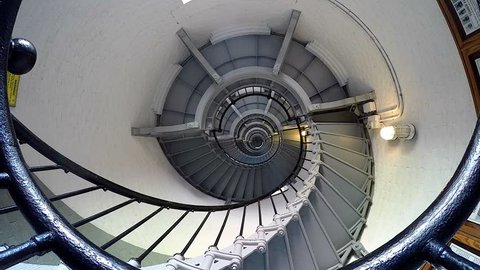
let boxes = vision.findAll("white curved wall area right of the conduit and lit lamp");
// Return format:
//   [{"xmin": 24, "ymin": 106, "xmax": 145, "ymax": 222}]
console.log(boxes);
[{"xmin": 342, "ymin": 0, "xmax": 476, "ymax": 251}]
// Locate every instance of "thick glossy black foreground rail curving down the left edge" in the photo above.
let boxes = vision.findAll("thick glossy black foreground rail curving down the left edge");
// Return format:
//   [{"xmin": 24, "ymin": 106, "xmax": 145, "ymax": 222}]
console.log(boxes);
[{"xmin": 0, "ymin": 0, "xmax": 136, "ymax": 270}]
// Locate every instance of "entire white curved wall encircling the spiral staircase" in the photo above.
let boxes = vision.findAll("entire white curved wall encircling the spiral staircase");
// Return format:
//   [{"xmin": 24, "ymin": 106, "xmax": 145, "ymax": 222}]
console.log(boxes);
[{"xmin": 9, "ymin": 0, "xmax": 475, "ymax": 260}]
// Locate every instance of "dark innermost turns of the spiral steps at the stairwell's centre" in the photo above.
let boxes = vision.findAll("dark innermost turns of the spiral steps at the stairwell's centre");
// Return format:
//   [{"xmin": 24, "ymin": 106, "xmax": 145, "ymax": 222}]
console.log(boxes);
[{"xmin": 158, "ymin": 83, "xmax": 305, "ymax": 202}]
